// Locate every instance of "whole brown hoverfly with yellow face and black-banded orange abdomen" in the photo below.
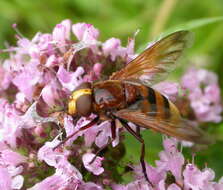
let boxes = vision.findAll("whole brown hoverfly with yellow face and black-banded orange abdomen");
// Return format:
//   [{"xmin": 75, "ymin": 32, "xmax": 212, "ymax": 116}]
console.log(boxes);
[{"xmin": 55, "ymin": 31, "xmax": 213, "ymax": 185}]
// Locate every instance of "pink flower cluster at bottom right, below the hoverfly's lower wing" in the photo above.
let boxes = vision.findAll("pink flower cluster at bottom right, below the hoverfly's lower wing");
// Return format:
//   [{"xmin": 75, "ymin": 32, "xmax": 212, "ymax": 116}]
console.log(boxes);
[{"xmin": 113, "ymin": 138, "xmax": 223, "ymax": 190}]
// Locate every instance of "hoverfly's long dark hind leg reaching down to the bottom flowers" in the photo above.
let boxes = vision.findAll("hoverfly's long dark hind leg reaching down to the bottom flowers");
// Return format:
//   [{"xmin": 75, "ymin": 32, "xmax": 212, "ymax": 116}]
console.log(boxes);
[{"xmin": 119, "ymin": 118, "xmax": 153, "ymax": 187}]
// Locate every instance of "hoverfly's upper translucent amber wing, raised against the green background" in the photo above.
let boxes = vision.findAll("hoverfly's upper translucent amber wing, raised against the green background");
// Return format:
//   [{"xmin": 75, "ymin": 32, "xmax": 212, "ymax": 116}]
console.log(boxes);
[{"xmin": 110, "ymin": 31, "xmax": 192, "ymax": 85}]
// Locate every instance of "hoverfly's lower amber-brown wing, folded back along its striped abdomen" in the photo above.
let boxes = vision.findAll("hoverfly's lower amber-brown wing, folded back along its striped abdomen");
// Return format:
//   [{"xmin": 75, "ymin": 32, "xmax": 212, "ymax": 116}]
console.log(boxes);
[{"xmin": 115, "ymin": 109, "xmax": 213, "ymax": 144}]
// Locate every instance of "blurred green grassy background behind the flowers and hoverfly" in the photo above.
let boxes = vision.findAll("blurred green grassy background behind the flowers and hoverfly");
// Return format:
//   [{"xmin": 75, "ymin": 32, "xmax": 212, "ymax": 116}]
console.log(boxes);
[{"xmin": 0, "ymin": 0, "xmax": 223, "ymax": 178}]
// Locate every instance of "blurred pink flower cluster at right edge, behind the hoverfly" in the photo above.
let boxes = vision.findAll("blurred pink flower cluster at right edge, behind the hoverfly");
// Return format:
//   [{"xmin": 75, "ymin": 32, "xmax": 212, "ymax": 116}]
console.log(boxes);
[{"xmin": 182, "ymin": 69, "xmax": 223, "ymax": 123}]
